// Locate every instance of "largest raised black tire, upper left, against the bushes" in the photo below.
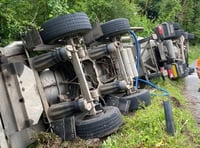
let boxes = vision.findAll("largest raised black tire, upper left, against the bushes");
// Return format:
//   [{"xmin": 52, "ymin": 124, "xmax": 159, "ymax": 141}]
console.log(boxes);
[{"xmin": 40, "ymin": 12, "xmax": 92, "ymax": 44}]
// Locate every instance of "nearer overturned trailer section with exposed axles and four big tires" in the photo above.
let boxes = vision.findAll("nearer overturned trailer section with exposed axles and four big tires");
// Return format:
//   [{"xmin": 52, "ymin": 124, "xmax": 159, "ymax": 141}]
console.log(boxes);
[{"xmin": 0, "ymin": 12, "xmax": 150, "ymax": 148}]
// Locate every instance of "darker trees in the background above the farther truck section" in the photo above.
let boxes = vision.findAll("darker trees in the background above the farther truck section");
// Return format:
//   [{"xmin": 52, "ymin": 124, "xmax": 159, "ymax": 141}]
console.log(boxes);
[{"xmin": 134, "ymin": 0, "xmax": 200, "ymax": 43}]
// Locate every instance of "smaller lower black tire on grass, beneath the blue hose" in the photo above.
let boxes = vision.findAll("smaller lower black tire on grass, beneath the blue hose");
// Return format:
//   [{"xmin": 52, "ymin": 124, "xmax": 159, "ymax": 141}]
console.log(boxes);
[{"xmin": 120, "ymin": 89, "xmax": 151, "ymax": 111}]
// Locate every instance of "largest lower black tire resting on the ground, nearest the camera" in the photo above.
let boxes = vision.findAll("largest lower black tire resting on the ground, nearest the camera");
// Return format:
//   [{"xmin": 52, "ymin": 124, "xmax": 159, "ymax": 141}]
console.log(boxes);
[{"xmin": 76, "ymin": 106, "xmax": 122, "ymax": 139}]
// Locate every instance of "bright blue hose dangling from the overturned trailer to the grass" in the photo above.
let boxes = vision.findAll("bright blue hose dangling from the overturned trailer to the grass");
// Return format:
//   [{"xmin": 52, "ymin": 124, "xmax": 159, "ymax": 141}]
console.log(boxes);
[{"xmin": 130, "ymin": 31, "xmax": 169, "ymax": 96}]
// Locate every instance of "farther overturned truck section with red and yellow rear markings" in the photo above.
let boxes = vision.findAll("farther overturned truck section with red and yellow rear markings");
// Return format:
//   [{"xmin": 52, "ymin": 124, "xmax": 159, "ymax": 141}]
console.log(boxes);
[{"xmin": 139, "ymin": 22, "xmax": 194, "ymax": 79}]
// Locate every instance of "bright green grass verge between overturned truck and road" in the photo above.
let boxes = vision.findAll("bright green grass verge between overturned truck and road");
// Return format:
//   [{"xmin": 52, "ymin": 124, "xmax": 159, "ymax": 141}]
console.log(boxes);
[{"xmin": 102, "ymin": 79, "xmax": 200, "ymax": 148}]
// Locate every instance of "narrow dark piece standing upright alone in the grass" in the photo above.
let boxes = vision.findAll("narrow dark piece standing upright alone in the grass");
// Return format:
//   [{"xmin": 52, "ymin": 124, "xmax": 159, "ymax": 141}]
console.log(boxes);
[{"xmin": 163, "ymin": 100, "xmax": 175, "ymax": 135}]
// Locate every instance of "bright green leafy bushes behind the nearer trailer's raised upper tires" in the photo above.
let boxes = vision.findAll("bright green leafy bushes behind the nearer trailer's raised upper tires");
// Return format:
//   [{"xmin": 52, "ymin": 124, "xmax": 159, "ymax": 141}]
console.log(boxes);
[{"xmin": 0, "ymin": 0, "xmax": 152, "ymax": 45}]
